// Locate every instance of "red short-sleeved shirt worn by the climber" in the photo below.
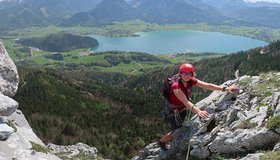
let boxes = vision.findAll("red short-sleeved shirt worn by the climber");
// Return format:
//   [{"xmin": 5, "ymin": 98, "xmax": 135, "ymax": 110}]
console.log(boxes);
[{"xmin": 169, "ymin": 77, "xmax": 198, "ymax": 111}]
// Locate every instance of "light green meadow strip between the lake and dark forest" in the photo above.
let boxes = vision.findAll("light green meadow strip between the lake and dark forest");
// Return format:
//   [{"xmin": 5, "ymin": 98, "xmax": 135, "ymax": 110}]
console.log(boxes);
[{"xmin": 24, "ymin": 50, "xmax": 223, "ymax": 75}]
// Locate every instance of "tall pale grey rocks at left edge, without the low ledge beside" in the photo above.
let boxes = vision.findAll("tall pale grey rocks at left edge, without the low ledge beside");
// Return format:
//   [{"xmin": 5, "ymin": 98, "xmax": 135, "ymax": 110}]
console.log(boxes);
[{"xmin": 0, "ymin": 41, "xmax": 59, "ymax": 160}]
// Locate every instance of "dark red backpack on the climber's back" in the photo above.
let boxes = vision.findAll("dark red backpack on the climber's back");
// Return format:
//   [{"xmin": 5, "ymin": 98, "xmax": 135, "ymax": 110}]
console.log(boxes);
[{"xmin": 162, "ymin": 73, "xmax": 192, "ymax": 101}]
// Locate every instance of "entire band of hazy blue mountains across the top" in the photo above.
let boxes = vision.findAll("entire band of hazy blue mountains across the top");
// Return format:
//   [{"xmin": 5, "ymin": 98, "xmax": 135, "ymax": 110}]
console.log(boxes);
[{"xmin": 0, "ymin": 0, "xmax": 280, "ymax": 29}]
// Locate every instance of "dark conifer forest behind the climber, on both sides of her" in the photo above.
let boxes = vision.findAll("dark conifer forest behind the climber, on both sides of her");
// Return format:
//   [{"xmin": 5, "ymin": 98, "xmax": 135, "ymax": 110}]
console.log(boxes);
[{"xmin": 15, "ymin": 41, "xmax": 280, "ymax": 159}]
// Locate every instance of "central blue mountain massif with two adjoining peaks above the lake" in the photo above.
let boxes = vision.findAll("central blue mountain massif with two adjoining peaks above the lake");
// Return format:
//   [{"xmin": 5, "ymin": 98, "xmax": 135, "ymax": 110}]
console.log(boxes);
[{"xmin": 62, "ymin": 0, "xmax": 227, "ymax": 25}]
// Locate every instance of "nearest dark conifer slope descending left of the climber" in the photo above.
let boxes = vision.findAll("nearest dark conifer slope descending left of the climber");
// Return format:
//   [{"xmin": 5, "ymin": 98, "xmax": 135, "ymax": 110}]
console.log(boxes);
[{"xmin": 15, "ymin": 68, "xmax": 163, "ymax": 159}]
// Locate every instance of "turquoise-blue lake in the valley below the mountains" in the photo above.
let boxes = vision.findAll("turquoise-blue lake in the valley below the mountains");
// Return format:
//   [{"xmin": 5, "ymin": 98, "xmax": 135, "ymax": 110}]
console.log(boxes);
[{"xmin": 91, "ymin": 30, "xmax": 267, "ymax": 54}]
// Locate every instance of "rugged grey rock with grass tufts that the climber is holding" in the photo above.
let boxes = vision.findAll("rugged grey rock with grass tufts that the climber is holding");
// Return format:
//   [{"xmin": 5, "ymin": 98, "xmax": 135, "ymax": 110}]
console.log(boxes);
[{"xmin": 133, "ymin": 73, "xmax": 280, "ymax": 160}]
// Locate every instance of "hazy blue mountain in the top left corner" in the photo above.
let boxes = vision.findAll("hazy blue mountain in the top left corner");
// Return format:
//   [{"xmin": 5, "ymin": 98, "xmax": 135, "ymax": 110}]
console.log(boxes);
[{"xmin": 0, "ymin": 0, "xmax": 101, "ymax": 29}]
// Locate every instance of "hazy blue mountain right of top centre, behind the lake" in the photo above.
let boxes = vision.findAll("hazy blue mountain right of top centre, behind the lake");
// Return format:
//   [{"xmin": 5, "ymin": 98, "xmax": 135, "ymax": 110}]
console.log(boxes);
[{"xmin": 132, "ymin": 0, "xmax": 225, "ymax": 24}]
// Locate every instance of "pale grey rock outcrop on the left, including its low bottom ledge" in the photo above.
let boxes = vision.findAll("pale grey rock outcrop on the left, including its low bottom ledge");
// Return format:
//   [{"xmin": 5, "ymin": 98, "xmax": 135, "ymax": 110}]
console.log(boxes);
[{"xmin": 0, "ymin": 40, "xmax": 102, "ymax": 160}]
